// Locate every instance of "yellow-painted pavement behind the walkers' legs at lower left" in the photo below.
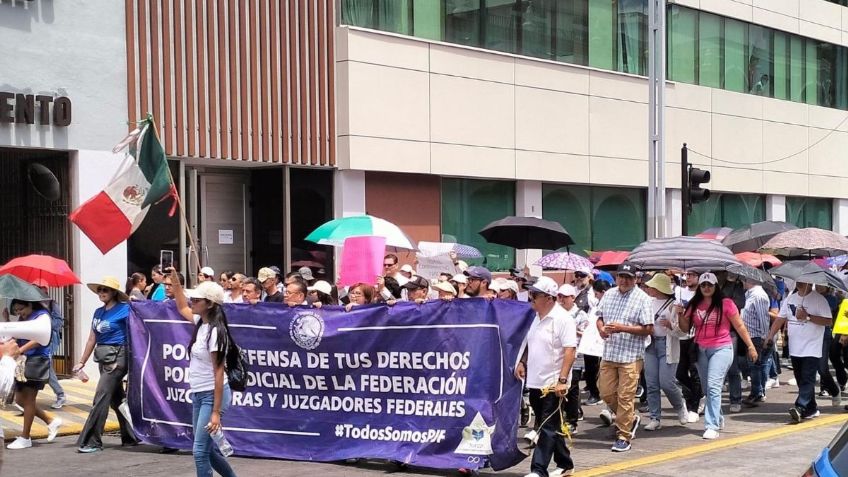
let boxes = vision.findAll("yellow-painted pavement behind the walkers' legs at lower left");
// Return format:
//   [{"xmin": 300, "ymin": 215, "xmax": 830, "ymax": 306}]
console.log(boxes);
[{"xmin": 0, "ymin": 379, "xmax": 118, "ymax": 441}]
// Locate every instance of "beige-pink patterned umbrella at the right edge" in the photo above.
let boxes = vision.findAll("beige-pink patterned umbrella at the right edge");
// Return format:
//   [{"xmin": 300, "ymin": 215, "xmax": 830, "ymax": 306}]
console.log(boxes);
[{"xmin": 760, "ymin": 227, "xmax": 848, "ymax": 257}]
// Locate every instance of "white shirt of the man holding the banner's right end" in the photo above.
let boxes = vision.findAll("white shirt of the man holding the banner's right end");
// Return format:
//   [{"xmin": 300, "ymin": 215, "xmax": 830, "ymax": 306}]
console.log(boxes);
[{"xmin": 527, "ymin": 304, "xmax": 577, "ymax": 389}]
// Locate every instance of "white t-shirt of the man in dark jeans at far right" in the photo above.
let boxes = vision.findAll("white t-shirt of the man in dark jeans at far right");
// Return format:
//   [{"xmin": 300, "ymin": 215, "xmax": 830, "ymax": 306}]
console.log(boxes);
[{"xmin": 780, "ymin": 290, "xmax": 831, "ymax": 358}]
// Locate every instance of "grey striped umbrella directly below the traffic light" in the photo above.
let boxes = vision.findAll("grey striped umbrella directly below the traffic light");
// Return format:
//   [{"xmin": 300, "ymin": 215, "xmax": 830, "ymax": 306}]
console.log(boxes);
[{"xmin": 627, "ymin": 236, "xmax": 739, "ymax": 270}]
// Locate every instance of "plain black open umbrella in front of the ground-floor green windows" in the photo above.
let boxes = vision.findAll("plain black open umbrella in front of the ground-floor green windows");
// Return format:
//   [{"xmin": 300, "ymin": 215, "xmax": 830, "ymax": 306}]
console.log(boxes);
[{"xmin": 480, "ymin": 216, "xmax": 574, "ymax": 250}]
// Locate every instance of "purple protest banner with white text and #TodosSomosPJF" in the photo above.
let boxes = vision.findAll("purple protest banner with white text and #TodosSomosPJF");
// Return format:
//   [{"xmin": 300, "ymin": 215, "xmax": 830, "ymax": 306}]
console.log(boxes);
[{"xmin": 129, "ymin": 299, "xmax": 534, "ymax": 470}]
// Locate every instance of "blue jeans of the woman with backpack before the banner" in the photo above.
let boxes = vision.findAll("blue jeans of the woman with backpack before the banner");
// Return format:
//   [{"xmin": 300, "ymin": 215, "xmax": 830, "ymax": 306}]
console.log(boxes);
[{"xmin": 191, "ymin": 384, "xmax": 236, "ymax": 477}]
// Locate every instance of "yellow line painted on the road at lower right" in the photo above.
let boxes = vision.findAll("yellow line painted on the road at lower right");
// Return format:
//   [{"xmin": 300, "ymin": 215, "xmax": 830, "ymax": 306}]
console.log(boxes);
[{"xmin": 577, "ymin": 414, "xmax": 848, "ymax": 477}]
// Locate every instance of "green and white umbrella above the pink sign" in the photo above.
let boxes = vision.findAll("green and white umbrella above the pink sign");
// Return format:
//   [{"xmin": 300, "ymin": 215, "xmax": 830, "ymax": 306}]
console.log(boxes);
[{"xmin": 306, "ymin": 215, "xmax": 416, "ymax": 250}]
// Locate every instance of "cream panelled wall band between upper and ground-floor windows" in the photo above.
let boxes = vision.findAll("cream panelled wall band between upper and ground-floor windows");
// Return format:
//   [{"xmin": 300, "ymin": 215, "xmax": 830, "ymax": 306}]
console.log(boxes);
[{"xmin": 337, "ymin": 27, "xmax": 848, "ymax": 198}]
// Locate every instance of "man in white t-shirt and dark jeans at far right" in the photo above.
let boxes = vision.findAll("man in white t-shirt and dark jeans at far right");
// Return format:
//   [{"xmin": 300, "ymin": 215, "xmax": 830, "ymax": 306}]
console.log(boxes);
[{"xmin": 766, "ymin": 282, "xmax": 833, "ymax": 422}]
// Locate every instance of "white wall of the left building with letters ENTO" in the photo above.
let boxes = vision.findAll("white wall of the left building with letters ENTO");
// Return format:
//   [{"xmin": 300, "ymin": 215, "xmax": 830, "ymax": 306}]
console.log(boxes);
[{"xmin": 0, "ymin": 0, "xmax": 127, "ymax": 375}]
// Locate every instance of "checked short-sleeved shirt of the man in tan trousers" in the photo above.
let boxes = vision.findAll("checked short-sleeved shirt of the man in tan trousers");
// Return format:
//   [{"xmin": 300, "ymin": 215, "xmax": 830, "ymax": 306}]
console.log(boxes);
[{"xmin": 598, "ymin": 287, "xmax": 654, "ymax": 363}]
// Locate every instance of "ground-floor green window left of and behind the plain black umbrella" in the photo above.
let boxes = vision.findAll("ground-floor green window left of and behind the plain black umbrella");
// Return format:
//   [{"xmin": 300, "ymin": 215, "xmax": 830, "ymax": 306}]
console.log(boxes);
[{"xmin": 442, "ymin": 178, "xmax": 515, "ymax": 270}]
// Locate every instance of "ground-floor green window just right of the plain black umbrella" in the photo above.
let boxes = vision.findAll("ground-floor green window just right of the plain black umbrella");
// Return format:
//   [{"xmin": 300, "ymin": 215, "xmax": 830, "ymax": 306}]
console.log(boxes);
[{"xmin": 542, "ymin": 184, "xmax": 646, "ymax": 254}]
